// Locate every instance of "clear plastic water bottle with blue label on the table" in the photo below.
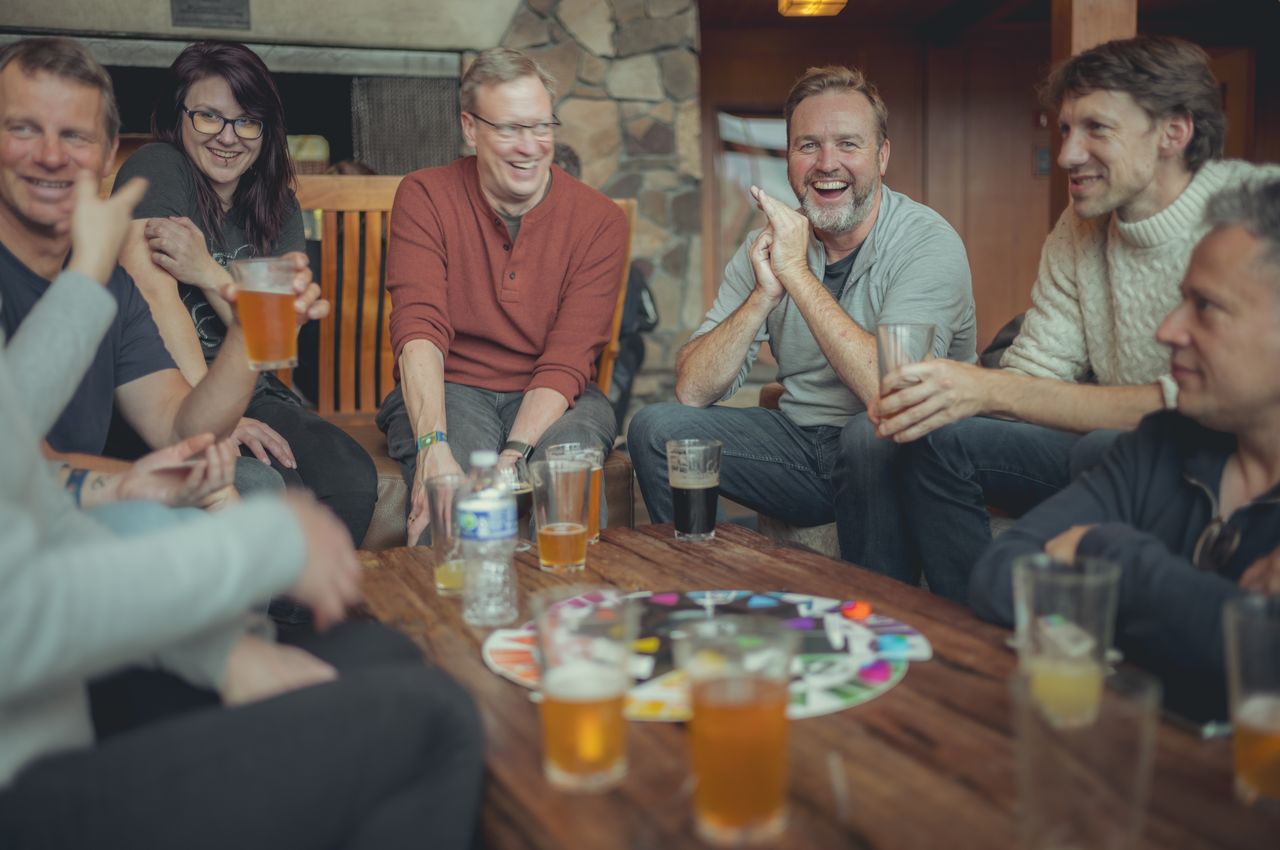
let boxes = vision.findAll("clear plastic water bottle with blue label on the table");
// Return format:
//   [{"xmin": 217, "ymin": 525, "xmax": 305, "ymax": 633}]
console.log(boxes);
[{"xmin": 453, "ymin": 452, "xmax": 517, "ymax": 627}]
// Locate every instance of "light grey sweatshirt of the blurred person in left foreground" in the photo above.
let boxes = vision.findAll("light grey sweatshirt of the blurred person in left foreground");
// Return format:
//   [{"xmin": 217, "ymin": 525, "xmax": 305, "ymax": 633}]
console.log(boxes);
[{"xmin": 0, "ymin": 271, "xmax": 305, "ymax": 787}]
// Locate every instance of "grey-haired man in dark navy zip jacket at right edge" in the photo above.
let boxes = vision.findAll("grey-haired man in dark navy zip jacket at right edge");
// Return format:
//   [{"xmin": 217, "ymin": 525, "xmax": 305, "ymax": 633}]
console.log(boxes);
[{"xmin": 970, "ymin": 180, "xmax": 1280, "ymax": 718}]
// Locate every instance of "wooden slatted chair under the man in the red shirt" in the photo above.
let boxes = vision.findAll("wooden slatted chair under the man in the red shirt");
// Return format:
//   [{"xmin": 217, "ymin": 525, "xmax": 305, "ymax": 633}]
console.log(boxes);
[{"xmin": 297, "ymin": 174, "xmax": 636, "ymax": 549}]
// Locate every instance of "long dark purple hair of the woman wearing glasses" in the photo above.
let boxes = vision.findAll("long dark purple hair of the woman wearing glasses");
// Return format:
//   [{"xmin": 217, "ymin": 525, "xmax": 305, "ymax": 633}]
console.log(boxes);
[{"xmin": 151, "ymin": 41, "xmax": 293, "ymax": 255}]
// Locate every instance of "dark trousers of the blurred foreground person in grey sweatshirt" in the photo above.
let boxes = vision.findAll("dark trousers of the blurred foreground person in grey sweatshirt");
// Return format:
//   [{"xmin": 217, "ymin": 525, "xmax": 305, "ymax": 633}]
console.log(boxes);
[{"xmin": 0, "ymin": 623, "xmax": 484, "ymax": 850}]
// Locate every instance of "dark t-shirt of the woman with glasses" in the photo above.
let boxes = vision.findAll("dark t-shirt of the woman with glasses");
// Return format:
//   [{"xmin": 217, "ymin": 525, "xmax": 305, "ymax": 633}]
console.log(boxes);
[{"xmin": 115, "ymin": 142, "xmax": 306, "ymax": 362}]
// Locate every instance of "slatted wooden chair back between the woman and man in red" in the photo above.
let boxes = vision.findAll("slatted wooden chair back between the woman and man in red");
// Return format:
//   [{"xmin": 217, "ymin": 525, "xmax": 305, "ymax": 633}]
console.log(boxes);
[{"xmin": 298, "ymin": 174, "xmax": 401, "ymax": 415}]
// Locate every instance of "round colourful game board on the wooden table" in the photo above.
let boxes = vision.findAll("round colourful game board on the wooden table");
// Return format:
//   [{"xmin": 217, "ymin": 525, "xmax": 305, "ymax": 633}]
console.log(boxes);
[{"xmin": 483, "ymin": 590, "xmax": 933, "ymax": 721}]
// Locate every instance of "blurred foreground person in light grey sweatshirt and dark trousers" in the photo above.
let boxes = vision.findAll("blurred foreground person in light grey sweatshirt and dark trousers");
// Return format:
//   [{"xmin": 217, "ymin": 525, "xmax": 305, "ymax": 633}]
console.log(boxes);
[{"xmin": 0, "ymin": 175, "xmax": 483, "ymax": 850}]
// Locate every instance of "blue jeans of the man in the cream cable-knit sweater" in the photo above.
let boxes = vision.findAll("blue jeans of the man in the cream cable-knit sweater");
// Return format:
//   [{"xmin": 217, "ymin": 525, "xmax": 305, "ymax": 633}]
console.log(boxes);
[{"xmin": 902, "ymin": 416, "xmax": 1120, "ymax": 602}]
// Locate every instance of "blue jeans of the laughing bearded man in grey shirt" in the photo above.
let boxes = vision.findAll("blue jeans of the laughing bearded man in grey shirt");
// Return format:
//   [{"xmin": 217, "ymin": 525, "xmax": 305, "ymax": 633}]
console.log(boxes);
[{"xmin": 627, "ymin": 405, "xmax": 919, "ymax": 582}]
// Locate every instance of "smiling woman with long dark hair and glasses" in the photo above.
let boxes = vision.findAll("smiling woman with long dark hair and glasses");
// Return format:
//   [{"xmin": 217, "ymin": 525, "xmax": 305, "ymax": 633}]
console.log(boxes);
[{"xmin": 116, "ymin": 41, "xmax": 378, "ymax": 544}]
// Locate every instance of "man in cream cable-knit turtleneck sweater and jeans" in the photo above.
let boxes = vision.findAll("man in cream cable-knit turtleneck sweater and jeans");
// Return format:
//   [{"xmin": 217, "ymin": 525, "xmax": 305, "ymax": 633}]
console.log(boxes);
[{"xmin": 874, "ymin": 37, "xmax": 1280, "ymax": 600}]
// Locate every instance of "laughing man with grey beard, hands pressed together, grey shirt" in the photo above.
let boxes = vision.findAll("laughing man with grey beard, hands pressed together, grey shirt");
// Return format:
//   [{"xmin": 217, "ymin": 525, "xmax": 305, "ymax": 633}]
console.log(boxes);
[{"xmin": 627, "ymin": 67, "xmax": 975, "ymax": 581}]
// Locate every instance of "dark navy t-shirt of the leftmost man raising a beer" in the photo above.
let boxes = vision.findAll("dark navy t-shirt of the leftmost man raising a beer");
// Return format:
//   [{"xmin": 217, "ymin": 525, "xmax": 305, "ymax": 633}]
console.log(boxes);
[{"xmin": 0, "ymin": 245, "xmax": 175, "ymax": 454}]
